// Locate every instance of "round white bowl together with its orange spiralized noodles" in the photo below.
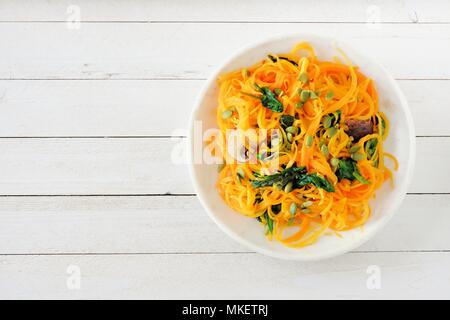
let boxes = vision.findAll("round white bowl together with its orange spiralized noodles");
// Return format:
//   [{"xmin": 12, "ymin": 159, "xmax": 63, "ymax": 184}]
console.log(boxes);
[{"xmin": 189, "ymin": 34, "xmax": 415, "ymax": 261}]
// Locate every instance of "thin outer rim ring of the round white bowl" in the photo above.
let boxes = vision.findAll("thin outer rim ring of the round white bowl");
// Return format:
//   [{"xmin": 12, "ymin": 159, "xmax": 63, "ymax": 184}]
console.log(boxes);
[{"xmin": 187, "ymin": 33, "xmax": 416, "ymax": 262}]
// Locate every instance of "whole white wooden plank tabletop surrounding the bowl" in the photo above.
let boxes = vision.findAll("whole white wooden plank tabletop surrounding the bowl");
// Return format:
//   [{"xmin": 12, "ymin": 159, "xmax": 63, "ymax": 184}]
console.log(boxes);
[{"xmin": 0, "ymin": 0, "xmax": 450, "ymax": 299}]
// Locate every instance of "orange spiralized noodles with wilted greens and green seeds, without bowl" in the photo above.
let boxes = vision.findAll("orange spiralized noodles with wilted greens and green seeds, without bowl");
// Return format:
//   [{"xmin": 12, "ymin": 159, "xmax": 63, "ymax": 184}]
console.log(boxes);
[{"xmin": 208, "ymin": 42, "xmax": 397, "ymax": 248}]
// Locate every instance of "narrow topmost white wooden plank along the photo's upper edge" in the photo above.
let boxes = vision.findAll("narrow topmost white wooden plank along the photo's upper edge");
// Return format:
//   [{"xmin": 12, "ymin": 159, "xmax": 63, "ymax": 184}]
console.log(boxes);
[{"xmin": 0, "ymin": 0, "xmax": 450, "ymax": 23}]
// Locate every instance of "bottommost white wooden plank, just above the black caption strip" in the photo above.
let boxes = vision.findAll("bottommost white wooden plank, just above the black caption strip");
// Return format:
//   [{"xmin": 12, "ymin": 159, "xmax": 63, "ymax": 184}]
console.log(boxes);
[{"xmin": 0, "ymin": 253, "xmax": 450, "ymax": 299}]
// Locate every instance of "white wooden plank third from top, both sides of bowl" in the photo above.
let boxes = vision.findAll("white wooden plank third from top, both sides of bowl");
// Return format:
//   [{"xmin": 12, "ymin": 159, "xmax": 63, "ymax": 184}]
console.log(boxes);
[{"xmin": 0, "ymin": 80, "xmax": 444, "ymax": 137}]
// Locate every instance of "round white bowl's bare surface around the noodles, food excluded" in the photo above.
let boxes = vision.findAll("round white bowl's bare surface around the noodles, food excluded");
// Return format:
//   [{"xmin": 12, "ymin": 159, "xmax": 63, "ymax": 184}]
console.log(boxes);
[{"xmin": 189, "ymin": 34, "xmax": 415, "ymax": 261}]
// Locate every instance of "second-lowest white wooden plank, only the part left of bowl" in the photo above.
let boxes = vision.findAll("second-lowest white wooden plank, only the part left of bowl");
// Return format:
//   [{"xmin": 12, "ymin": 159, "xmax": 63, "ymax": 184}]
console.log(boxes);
[{"xmin": 0, "ymin": 196, "xmax": 246, "ymax": 254}]
